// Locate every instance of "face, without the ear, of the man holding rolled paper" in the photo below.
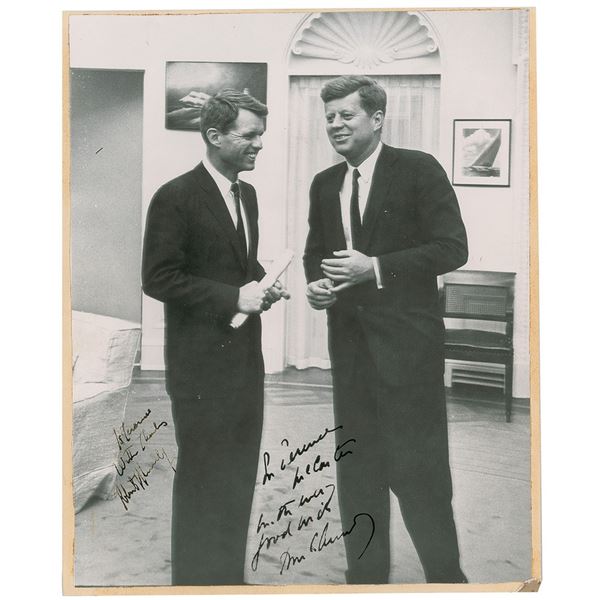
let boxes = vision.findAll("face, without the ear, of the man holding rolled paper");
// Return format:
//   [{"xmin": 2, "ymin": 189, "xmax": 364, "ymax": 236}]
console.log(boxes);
[{"xmin": 218, "ymin": 109, "xmax": 265, "ymax": 174}]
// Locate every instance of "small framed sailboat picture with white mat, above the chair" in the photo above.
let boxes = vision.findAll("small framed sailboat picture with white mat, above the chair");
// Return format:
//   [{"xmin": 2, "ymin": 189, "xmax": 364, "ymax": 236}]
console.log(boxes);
[{"xmin": 452, "ymin": 119, "xmax": 511, "ymax": 187}]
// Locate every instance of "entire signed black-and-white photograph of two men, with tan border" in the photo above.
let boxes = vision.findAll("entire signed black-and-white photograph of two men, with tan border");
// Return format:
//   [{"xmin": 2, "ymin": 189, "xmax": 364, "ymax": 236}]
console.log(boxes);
[{"xmin": 64, "ymin": 8, "xmax": 541, "ymax": 594}]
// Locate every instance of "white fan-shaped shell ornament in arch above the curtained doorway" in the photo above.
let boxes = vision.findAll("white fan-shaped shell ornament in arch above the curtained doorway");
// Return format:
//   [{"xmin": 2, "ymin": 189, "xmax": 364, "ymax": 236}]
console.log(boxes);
[{"xmin": 292, "ymin": 11, "xmax": 438, "ymax": 69}]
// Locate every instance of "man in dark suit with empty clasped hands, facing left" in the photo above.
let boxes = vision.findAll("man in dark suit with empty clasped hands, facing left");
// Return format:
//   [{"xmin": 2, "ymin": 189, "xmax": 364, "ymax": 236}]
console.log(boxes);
[{"xmin": 304, "ymin": 76, "xmax": 467, "ymax": 583}]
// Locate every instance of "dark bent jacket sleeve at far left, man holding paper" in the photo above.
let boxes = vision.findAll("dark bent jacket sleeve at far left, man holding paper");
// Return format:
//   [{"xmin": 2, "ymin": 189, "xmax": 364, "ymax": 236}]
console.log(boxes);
[{"xmin": 142, "ymin": 186, "xmax": 239, "ymax": 316}]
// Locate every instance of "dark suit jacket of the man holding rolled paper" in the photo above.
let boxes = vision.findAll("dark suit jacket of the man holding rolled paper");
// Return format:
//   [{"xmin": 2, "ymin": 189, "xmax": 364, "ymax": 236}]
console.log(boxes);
[{"xmin": 142, "ymin": 163, "xmax": 264, "ymax": 397}]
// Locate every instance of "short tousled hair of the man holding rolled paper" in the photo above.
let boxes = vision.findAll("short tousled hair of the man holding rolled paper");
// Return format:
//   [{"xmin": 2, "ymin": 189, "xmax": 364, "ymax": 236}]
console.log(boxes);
[{"xmin": 200, "ymin": 89, "xmax": 269, "ymax": 144}]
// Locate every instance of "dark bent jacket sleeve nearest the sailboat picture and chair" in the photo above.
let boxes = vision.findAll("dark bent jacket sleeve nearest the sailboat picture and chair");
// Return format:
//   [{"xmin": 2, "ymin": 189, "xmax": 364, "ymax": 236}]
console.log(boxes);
[{"xmin": 378, "ymin": 154, "xmax": 468, "ymax": 286}]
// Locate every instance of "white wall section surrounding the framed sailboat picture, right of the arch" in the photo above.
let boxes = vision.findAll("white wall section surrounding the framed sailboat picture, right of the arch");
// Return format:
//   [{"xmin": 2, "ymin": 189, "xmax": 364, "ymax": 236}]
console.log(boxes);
[{"xmin": 431, "ymin": 11, "xmax": 517, "ymax": 271}]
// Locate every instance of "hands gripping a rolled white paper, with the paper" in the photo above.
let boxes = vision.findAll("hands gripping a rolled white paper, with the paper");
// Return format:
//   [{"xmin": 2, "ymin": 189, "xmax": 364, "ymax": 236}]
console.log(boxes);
[{"xmin": 229, "ymin": 250, "xmax": 294, "ymax": 329}]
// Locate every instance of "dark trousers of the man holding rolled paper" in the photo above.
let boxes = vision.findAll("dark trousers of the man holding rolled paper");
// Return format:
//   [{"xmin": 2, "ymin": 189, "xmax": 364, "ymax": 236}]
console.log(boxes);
[{"xmin": 171, "ymin": 373, "xmax": 264, "ymax": 585}]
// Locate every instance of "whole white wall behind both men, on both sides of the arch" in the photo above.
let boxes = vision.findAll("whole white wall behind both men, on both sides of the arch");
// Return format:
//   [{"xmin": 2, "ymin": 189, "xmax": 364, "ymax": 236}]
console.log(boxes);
[{"xmin": 70, "ymin": 11, "xmax": 529, "ymax": 396}]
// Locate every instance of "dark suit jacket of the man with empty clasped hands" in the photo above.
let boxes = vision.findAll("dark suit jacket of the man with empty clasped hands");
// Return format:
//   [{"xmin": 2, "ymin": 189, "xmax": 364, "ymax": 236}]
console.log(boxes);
[{"xmin": 304, "ymin": 145, "xmax": 467, "ymax": 385}]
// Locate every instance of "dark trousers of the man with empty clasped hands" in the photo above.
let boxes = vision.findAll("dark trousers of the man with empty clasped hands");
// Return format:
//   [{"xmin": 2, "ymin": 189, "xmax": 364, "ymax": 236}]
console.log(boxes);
[{"xmin": 333, "ymin": 332, "xmax": 465, "ymax": 583}]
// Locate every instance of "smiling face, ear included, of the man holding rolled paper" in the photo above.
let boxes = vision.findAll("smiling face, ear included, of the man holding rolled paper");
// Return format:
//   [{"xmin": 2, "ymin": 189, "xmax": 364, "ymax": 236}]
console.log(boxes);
[{"xmin": 207, "ymin": 109, "xmax": 265, "ymax": 181}]
